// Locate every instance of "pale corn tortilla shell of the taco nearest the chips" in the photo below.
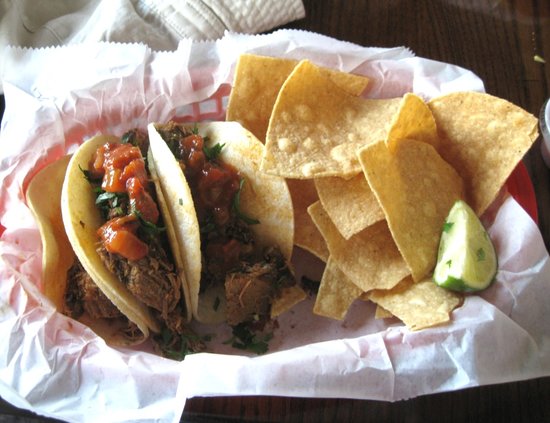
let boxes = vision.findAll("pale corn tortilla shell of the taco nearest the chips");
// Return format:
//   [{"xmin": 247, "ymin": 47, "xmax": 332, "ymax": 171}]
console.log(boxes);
[{"xmin": 148, "ymin": 122, "xmax": 295, "ymax": 323}]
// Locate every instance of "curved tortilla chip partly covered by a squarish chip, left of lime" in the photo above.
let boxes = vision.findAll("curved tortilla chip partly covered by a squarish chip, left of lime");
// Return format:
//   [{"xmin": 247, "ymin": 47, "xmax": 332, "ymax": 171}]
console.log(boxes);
[{"xmin": 308, "ymin": 202, "xmax": 410, "ymax": 291}]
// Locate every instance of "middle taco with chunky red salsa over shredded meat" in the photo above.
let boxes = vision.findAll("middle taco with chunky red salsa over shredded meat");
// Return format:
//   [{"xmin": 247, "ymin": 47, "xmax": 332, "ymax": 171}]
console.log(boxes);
[{"xmin": 58, "ymin": 130, "xmax": 197, "ymax": 352}]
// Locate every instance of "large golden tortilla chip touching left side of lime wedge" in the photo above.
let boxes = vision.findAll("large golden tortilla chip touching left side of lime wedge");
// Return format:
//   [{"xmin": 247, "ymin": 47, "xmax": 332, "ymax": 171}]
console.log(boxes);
[{"xmin": 362, "ymin": 140, "xmax": 463, "ymax": 281}]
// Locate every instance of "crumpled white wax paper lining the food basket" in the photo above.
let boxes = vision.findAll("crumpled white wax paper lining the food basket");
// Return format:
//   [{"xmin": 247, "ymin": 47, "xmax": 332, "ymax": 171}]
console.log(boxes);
[{"xmin": 0, "ymin": 30, "xmax": 550, "ymax": 422}]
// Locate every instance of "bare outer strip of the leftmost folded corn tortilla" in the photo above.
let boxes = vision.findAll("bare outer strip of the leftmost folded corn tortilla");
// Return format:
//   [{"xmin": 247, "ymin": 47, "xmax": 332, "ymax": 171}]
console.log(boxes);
[{"xmin": 26, "ymin": 156, "xmax": 75, "ymax": 312}]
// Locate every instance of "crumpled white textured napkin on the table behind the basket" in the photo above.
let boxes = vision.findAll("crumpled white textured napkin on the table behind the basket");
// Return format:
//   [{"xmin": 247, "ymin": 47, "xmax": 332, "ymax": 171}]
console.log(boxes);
[{"xmin": 0, "ymin": 0, "xmax": 305, "ymax": 93}]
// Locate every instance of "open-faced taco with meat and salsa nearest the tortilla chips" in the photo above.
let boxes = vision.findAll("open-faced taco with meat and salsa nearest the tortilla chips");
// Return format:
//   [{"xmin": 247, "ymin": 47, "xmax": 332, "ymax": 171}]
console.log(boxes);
[{"xmin": 148, "ymin": 122, "xmax": 306, "ymax": 327}]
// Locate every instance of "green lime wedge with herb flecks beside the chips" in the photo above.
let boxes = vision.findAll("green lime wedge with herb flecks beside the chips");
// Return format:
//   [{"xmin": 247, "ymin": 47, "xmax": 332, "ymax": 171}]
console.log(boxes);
[{"xmin": 433, "ymin": 200, "xmax": 498, "ymax": 292}]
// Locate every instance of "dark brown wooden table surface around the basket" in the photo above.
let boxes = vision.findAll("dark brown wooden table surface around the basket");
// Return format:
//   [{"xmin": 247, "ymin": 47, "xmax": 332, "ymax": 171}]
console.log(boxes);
[{"xmin": 0, "ymin": 0, "xmax": 550, "ymax": 423}]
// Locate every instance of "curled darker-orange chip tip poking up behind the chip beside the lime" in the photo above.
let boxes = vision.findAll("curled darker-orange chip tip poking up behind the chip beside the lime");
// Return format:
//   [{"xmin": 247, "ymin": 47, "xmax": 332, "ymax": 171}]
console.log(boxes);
[{"xmin": 386, "ymin": 93, "xmax": 439, "ymax": 152}]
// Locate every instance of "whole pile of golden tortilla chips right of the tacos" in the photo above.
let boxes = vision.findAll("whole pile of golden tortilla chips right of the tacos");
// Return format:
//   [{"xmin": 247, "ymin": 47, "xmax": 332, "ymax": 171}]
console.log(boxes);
[{"xmin": 227, "ymin": 55, "xmax": 538, "ymax": 330}]
